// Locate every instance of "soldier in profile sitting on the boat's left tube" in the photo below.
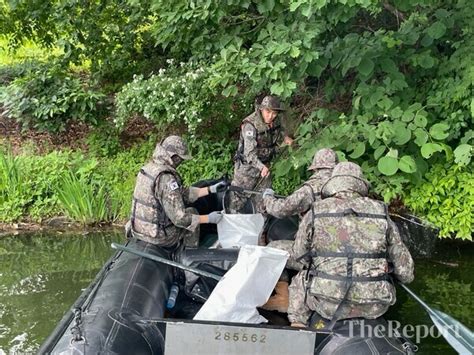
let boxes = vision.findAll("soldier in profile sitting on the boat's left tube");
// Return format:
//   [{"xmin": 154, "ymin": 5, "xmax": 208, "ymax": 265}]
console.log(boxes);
[{"xmin": 126, "ymin": 136, "xmax": 226, "ymax": 249}]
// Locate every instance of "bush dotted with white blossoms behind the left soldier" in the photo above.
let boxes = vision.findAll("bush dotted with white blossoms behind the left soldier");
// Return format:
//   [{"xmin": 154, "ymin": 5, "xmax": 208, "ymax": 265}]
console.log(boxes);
[{"xmin": 115, "ymin": 60, "xmax": 250, "ymax": 138}]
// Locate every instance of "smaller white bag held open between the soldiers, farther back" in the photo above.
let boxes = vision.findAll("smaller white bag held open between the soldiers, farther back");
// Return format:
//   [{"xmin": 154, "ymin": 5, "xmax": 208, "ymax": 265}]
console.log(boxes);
[{"xmin": 217, "ymin": 213, "xmax": 265, "ymax": 248}]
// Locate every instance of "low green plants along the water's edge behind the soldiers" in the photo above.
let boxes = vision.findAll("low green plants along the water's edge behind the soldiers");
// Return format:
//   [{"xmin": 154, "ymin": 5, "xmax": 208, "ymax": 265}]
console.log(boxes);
[{"xmin": 0, "ymin": 136, "xmax": 474, "ymax": 240}]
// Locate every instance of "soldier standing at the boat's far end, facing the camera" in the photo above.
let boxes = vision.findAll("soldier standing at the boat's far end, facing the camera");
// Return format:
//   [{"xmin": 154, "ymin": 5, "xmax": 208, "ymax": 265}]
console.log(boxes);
[{"xmin": 229, "ymin": 96, "xmax": 292, "ymax": 213}]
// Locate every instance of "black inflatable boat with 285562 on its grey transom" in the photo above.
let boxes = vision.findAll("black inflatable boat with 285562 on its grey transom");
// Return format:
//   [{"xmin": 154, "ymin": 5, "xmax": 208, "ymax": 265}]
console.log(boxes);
[{"xmin": 39, "ymin": 185, "xmax": 411, "ymax": 355}]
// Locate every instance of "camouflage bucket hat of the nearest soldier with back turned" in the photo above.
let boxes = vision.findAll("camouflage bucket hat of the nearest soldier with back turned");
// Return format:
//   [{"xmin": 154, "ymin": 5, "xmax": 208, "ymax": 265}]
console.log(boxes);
[{"xmin": 321, "ymin": 162, "xmax": 370, "ymax": 197}]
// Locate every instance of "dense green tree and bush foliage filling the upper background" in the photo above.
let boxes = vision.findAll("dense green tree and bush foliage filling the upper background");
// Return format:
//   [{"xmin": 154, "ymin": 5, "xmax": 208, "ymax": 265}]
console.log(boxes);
[{"xmin": 0, "ymin": 0, "xmax": 474, "ymax": 239}]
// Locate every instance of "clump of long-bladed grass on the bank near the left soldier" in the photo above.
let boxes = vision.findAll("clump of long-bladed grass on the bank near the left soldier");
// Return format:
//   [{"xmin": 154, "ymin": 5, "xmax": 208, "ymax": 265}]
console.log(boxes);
[{"xmin": 57, "ymin": 171, "xmax": 113, "ymax": 225}]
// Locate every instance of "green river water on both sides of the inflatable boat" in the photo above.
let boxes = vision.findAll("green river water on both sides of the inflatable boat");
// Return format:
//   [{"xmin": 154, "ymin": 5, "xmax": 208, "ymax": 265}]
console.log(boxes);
[{"xmin": 0, "ymin": 231, "xmax": 474, "ymax": 354}]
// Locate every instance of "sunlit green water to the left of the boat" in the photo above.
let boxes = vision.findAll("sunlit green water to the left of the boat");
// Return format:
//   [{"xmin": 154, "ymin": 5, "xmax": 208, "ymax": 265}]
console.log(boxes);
[{"xmin": 0, "ymin": 231, "xmax": 122, "ymax": 353}]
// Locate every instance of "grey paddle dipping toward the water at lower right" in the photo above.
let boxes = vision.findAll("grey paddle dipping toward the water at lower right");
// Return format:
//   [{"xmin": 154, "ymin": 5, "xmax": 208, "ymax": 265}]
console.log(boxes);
[{"xmin": 399, "ymin": 284, "xmax": 474, "ymax": 354}]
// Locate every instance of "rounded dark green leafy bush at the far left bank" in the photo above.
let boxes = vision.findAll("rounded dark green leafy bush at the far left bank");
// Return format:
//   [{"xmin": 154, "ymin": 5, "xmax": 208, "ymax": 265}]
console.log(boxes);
[{"xmin": 0, "ymin": 65, "xmax": 105, "ymax": 132}]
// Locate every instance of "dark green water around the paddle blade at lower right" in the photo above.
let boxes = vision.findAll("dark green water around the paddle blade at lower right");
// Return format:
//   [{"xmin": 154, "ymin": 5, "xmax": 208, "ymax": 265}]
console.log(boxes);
[{"xmin": 387, "ymin": 243, "xmax": 474, "ymax": 354}]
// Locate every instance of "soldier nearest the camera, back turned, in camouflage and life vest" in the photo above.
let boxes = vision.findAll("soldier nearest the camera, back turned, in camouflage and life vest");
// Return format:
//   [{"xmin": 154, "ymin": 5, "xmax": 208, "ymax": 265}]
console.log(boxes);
[{"xmin": 288, "ymin": 162, "xmax": 414, "ymax": 324}]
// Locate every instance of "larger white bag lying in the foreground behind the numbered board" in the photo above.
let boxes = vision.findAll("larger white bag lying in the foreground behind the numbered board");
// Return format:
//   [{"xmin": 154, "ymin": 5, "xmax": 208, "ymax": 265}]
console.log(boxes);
[{"xmin": 194, "ymin": 245, "xmax": 289, "ymax": 323}]
